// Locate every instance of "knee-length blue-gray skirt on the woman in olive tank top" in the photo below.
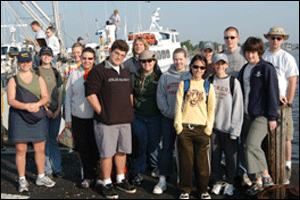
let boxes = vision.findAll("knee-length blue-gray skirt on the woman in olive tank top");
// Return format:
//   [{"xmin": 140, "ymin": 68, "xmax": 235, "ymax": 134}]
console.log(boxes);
[{"xmin": 8, "ymin": 107, "xmax": 48, "ymax": 143}]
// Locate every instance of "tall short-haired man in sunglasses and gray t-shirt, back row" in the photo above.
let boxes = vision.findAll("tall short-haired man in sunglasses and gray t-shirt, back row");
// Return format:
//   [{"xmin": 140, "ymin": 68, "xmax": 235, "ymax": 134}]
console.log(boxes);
[{"xmin": 223, "ymin": 26, "xmax": 247, "ymax": 78}]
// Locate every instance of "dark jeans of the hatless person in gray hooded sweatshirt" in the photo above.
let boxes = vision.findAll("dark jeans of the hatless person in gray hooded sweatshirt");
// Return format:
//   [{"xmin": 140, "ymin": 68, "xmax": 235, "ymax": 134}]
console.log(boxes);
[{"xmin": 159, "ymin": 116, "xmax": 176, "ymax": 176}]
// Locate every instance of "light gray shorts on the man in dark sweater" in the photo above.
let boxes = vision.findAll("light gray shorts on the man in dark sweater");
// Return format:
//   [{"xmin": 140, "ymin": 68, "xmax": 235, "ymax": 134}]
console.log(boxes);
[{"xmin": 94, "ymin": 120, "xmax": 132, "ymax": 158}]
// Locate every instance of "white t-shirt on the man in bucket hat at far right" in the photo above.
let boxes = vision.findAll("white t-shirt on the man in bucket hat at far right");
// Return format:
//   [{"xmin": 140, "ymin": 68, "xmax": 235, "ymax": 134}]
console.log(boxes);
[{"xmin": 262, "ymin": 49, "xmax": 299, "ymax": 97}]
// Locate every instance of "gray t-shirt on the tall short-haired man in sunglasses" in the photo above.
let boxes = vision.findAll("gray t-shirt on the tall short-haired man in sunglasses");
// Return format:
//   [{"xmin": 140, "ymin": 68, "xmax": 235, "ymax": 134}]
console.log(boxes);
[{"xmin": 223, "ymin": 47, "xmax": 247, "ymax": 78}]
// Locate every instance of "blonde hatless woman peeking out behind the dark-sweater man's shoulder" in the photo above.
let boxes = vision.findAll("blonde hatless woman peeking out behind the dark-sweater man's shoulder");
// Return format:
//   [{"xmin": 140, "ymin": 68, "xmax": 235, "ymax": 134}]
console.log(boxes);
[{"xmin": 124, "ymin": 37, "xmax": 149, "ymax": 74}]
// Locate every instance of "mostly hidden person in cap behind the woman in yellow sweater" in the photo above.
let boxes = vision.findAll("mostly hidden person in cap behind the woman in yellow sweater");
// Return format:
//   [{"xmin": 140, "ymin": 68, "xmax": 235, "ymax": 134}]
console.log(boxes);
[{"xmin": 200, "ymin": 41, "xmax": 215, "ymax": 79}]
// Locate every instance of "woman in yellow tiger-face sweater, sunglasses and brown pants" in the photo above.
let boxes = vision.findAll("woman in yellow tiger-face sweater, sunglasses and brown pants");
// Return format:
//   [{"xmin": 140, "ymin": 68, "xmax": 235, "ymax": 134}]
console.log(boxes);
[{"xmin": 174, "ymin": 55, "xmax": 215, "ymax": 199}]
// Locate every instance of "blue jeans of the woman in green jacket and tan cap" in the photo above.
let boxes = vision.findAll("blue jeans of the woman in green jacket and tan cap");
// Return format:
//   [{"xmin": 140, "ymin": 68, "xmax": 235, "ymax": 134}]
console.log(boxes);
[{"xmin": 131, "ymin": 114, "xmax": 161, "ymax": 173}]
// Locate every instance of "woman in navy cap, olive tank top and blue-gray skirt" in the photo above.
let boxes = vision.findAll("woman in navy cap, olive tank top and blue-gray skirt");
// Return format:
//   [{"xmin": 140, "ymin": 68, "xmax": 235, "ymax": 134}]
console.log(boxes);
[{"xmin": 7, "ymin": 52, "xmax": 55, "ymax": 192}]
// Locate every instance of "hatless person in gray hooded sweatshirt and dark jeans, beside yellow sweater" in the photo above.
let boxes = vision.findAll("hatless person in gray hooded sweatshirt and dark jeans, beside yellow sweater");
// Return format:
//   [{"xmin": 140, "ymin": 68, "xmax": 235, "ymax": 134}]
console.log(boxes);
[{"xmin": 153, "ymin": 48, "xmax": 192, "ymax": 194}]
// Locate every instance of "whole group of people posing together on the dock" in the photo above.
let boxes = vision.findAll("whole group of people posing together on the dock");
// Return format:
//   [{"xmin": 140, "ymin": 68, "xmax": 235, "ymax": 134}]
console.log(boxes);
[{"xmin": 7, "ymin": 24, "xmax": 299, "ymax": 199}]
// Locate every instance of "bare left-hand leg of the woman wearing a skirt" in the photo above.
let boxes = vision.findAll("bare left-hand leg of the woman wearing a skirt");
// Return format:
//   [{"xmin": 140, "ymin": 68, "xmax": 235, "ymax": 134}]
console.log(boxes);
[{"xmin": 15, "ymin": 142, "xmax": 27, "ymax": 177}]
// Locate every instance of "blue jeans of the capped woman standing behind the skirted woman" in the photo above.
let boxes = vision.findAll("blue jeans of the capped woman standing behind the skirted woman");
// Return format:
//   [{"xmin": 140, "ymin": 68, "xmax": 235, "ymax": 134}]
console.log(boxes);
[{"xmin": 45, "ymin": 115, "xmax": 62, "ymax": 174}]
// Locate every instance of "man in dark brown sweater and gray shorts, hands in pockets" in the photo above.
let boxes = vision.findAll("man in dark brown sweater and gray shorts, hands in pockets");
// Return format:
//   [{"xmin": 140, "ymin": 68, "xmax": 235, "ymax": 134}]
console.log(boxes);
[{"xmin": 85, "ymin": 40, "xmax": 136, "ymax": 199}]
